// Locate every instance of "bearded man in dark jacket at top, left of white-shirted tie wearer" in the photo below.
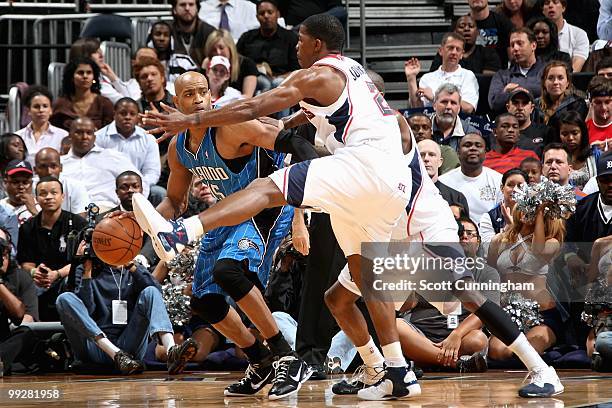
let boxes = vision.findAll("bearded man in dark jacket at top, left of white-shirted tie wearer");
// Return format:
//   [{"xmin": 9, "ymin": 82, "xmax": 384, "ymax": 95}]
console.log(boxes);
[{"xmin": 170, "ymin": 0, "xmax": 215, "ymax": 66}]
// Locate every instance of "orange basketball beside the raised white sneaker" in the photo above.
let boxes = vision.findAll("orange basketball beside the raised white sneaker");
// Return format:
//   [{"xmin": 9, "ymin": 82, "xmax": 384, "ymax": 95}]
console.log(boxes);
[{"xmin": 92, "ymin": 217, "xmax": 142, "ymax": 266}]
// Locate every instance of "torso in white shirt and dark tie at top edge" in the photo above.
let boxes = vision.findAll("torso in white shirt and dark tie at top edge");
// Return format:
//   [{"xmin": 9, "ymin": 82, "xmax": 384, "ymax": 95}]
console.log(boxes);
[{"xmin": 198, "ymin": 0, "xmax": 259, "ymax": 41}]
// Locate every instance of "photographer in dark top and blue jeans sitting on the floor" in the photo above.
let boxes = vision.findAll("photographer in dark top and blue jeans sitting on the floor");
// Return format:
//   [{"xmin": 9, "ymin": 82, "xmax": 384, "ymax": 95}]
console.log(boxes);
[{"xmin": 56, "ymin": 241, "xmax": 197, "ymax": 374}]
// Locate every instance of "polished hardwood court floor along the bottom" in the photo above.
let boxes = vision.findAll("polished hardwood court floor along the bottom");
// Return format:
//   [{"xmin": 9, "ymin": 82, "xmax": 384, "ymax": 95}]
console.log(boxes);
[{"xmin": 0, "ymin": 370, "xmax": 612, "ymax": 408}]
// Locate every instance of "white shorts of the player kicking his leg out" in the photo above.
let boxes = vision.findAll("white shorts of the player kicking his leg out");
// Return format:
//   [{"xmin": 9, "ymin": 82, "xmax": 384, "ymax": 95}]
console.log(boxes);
[{"xmin": 269, "ymin": 144, "xmax": 411, "ymax": 257}]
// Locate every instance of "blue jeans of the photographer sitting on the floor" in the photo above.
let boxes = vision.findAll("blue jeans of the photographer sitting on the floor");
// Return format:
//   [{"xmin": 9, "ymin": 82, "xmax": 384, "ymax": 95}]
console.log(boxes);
[{"xmin": 55, "ymin": 286, "xmax": 173, "ymax": 366}]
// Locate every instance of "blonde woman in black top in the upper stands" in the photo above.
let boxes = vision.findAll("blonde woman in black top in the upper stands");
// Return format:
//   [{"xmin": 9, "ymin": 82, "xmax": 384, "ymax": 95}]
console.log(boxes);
[{"xmin": 202, "ymin": 30, "xmax": 259, "ymax": 98}]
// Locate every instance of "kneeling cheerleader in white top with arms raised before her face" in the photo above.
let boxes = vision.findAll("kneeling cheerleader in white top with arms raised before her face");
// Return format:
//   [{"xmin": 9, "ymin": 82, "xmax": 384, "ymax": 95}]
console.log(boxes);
[{"xmin": 487, "ymin": 203, "xmax": 565, "ymax": 360}]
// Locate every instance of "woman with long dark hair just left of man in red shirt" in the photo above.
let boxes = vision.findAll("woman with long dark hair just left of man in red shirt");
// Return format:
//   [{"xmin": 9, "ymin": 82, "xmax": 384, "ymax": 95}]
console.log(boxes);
[{"xmin": 553, "ymin": 111, "xmax": 597, "ymax": 191}]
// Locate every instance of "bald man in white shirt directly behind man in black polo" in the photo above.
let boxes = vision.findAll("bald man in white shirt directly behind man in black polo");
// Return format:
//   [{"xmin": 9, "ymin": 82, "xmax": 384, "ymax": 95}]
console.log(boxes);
[{"xmin": 34, "ymin": 147, "xmax": 91, "ymax": 214}]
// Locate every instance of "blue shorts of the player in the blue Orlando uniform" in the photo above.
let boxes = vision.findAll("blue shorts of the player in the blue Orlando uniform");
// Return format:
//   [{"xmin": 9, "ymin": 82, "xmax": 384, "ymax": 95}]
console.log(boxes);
[{"xmin": 192, "ymin": 206, "xmax": 293, "ymax": 298}]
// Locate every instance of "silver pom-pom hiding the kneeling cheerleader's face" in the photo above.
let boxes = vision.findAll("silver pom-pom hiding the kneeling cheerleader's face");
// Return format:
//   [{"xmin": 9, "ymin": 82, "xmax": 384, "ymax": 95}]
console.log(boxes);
[{"xmin": 512, "ymin": 177, "xmax": 576, "ymax": 222}]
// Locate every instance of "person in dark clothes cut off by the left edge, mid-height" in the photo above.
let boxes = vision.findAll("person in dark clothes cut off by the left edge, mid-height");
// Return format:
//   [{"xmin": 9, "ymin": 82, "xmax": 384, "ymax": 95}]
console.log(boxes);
[{"xmin": 0, "ymin": 227, "xmax": 38, "ymax": 324}]
